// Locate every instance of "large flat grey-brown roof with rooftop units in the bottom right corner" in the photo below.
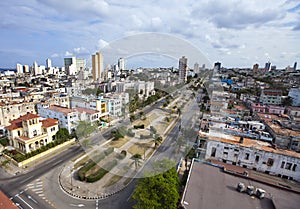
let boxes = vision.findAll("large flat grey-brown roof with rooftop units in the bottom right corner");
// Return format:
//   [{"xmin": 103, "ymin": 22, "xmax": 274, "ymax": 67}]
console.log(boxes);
[{"xmin": 181, "ymin": 161, "xmax": 300, "ymax": 209}]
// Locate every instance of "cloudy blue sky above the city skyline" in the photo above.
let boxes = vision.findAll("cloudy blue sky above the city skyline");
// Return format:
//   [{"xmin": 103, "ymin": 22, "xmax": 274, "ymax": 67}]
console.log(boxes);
[{"xmin": 0, "ymin": 0, "xmax": 300, "ymax": 68}]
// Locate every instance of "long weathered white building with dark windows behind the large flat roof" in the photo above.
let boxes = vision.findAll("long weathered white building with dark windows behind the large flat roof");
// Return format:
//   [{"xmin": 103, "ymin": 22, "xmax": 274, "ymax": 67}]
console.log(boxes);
[{"xmin": 205, "ymin": 136, "xmax": 300, "ymax": 181}]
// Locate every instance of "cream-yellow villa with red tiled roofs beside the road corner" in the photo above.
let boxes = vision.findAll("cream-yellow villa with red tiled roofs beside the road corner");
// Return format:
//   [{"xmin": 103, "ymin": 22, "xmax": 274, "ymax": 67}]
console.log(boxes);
[{"xmin": 6, "ymin": 113, "xmax": 58, "ymax": 153}]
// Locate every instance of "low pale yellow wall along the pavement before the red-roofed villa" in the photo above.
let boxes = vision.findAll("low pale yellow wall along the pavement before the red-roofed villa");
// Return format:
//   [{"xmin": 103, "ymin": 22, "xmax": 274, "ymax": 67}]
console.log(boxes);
[{"xmin": 4, "ymin": 138, "xmax": 75, "ymax": 167}]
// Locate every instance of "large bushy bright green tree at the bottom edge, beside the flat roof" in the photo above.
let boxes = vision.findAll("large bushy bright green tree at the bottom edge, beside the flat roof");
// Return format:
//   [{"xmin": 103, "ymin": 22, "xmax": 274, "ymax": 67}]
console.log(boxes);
[{"xmin": 132, "ymin": 160, "xmax": 180, "ymax": 209}]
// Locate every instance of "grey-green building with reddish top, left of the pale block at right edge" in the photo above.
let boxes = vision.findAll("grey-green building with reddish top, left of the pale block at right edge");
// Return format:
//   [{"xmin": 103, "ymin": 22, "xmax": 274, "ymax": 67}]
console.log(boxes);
[{"xmin": 259, "ymin": 89, "xmax": 282, "ymax": 105}]
